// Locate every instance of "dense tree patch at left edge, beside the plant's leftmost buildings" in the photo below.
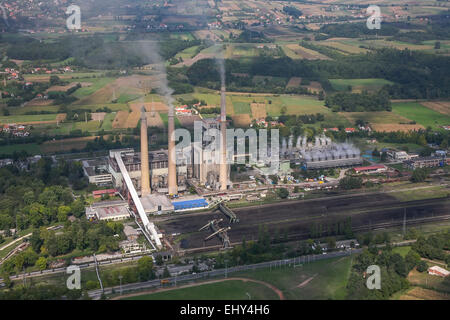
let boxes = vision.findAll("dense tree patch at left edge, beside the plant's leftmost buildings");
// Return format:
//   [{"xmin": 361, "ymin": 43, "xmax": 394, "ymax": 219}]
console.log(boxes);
[{"xmin": 0, "ymin": 158, "xmax": 87, "ymax": 230}]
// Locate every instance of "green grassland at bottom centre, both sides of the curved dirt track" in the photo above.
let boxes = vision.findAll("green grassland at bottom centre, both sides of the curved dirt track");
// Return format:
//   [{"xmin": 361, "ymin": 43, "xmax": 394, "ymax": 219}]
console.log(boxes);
[{"xmin": 121, "ymin": 256, "xmax": 352, "ymax": 300}]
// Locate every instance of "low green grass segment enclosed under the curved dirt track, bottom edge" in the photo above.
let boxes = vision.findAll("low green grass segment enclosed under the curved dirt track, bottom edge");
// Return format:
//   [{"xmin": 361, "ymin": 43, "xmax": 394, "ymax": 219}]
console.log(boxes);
[{"xmin": 123, "ymin": 280, "xmax": 278, "ymax": 300}]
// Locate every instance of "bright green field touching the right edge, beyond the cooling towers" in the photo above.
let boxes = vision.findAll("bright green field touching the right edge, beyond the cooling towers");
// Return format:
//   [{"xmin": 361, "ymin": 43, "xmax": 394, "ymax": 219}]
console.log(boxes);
[{"xmin": 392, "ymin": 102, "xmax": 450, "ymax": 129}]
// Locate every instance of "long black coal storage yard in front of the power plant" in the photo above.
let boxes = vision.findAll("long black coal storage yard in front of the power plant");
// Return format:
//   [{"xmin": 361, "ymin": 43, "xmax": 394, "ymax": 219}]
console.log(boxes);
[{"xmin": 157, "ymin": 194, "xmax": 450, "ymax": 249}]
